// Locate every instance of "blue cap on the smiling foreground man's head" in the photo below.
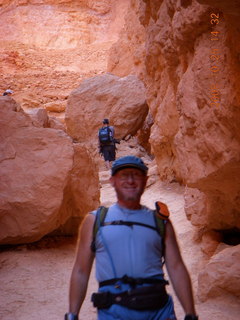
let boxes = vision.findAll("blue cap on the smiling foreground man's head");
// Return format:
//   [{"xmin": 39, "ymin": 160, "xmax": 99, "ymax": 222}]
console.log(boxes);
[{"xmin": 112, "ymin": 156, "xmax": 148, "ymax": 176}]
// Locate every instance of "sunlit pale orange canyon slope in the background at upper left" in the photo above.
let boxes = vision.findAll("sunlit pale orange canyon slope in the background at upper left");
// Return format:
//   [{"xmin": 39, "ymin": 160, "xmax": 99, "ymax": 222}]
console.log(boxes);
[{"xmin": 0, "ymin": 0, "xmax": 129, "ymax": 117}]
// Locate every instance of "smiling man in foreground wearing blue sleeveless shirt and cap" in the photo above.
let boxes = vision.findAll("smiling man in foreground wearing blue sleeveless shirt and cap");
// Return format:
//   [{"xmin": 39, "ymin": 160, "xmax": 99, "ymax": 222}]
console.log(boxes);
[{"xmin": 65, "ymin": 156, "xmax": 198, "ymax": 320}]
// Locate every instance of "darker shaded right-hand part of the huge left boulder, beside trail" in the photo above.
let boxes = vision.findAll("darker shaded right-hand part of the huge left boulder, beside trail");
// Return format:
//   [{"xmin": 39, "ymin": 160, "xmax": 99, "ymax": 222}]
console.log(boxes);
[{"xmin": 55, "ymin": 143, "xmax": 100, "ymax": 235}]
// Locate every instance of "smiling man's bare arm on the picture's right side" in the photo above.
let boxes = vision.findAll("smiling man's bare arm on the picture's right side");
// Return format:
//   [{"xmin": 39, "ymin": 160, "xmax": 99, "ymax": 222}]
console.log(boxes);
[{"xmin": 165, "ymin": 221, "xmax": 196, "ymax": 315}]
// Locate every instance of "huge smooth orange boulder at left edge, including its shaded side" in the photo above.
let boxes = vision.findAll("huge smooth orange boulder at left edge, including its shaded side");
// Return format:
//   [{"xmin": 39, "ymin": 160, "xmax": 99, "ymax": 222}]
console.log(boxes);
[{"xmin": 0, "ymin": 97, "xmax": 99, "ymax": 244}]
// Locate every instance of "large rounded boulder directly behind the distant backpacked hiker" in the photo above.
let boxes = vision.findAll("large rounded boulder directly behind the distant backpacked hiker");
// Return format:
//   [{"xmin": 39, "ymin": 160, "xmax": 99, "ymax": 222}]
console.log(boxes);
[{"xmin": 66, "ymin": 74, "xmax": 148, "ymax": 146}]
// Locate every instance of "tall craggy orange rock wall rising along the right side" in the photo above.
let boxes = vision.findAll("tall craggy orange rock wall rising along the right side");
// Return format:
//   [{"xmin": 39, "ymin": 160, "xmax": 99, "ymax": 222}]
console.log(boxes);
[{"xmin": 108, "ymin": 0, "xmax": 240, "ymax": 302}]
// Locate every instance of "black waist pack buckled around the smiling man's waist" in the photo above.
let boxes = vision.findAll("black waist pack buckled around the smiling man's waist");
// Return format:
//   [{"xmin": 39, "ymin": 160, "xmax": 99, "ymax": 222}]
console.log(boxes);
[{"xmin": 91, "ymin": 283, "xmax": 168, "ymax": 310}]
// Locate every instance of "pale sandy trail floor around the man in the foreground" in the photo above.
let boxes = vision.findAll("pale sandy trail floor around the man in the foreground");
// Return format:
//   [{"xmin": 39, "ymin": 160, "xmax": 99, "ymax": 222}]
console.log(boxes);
[{"xmin": 0, "ymin": 164, "xmax": 240, "ymax": 320}]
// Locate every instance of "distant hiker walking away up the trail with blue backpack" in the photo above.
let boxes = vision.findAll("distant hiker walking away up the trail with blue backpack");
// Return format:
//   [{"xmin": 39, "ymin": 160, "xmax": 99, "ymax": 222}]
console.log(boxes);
[{"xmin": 98, "ymin": 119, "xmax": 116, "ymax": 169}]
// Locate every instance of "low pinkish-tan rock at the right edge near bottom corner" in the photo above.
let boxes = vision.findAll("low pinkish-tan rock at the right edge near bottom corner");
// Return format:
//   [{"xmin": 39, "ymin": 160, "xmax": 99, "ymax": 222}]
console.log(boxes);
[{"xmin": 198, "ymin": 245, "xmax": 240, "ymax": 302}]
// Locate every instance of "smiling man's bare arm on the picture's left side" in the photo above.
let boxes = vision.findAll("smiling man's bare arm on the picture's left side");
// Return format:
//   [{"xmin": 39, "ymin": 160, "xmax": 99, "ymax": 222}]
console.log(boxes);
[{"xmin": 69, "ymin": 214, "xmax": 95, "ymax": 315}]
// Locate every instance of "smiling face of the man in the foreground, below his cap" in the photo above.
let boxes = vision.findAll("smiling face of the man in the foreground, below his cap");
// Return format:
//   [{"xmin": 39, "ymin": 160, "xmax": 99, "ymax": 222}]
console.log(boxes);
[{"xmin": 110, "ymin": 168, "xmax": 148, "ymax": 202}]
